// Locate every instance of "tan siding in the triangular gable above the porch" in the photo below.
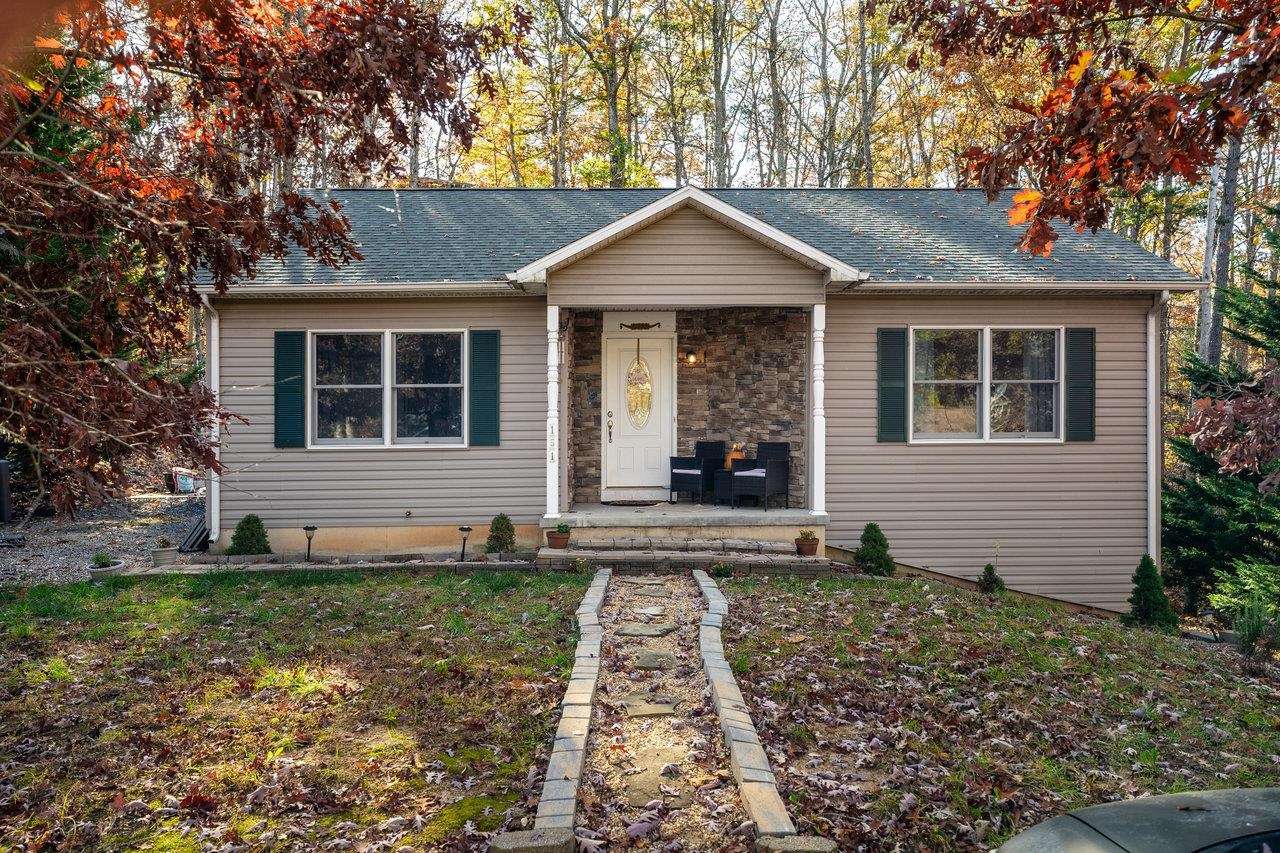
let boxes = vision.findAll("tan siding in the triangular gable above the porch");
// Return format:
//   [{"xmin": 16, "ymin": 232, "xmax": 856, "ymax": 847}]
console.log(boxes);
[{"xmin": 547, "ymin": 209, "xmax": 823, "ymax": 309}]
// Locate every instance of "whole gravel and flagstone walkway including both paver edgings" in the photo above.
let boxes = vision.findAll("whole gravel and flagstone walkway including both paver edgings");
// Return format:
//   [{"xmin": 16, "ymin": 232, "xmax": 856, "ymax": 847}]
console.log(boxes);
[{"xmin": 492, "ymin": 569, "xmax": 836, "ymax": 853}]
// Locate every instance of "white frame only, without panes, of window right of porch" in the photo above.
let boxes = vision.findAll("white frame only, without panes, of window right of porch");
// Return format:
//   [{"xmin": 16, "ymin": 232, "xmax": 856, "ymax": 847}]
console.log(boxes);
[{"xmin": 906, "ymin": 323, "xmax": 1066, "ymax": 444}]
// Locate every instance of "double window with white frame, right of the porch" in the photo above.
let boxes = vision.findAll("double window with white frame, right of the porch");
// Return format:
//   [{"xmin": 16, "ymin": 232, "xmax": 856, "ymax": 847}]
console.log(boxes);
[{"xmin": 911, "ymin": 328, "xmax": 1061, "ymax": 441}]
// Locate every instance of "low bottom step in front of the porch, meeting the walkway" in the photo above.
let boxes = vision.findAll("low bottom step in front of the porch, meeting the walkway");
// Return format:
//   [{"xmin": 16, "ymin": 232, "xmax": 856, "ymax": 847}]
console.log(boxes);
[{"xmin": 535, "ymin": 548, "xmax": 832, "ymax": 578}]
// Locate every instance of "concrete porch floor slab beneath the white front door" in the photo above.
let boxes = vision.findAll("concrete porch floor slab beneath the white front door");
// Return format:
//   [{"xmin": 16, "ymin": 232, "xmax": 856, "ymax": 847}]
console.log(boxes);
[{"xmin": 541, "ymin": 502, "xmax": 828, "ymax": 528}]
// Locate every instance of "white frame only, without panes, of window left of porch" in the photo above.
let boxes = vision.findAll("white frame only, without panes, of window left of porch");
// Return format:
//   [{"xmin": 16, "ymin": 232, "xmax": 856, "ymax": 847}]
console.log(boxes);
[{"xmin": 305, "ymin": 328, "xmax": 471, "ymax": 451}]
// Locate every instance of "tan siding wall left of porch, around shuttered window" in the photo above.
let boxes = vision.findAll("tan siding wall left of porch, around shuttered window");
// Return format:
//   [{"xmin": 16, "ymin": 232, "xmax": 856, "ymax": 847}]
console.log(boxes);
[{"xmin": 218, "ymin": 297, "xmax": 547, "ymax": 533}]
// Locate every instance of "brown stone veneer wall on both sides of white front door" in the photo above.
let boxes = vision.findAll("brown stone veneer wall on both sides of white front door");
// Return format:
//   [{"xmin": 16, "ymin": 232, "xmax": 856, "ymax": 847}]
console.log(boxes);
[{"xmin": 570, "ymin": 307, "xmax": 809, "ymax": 507}]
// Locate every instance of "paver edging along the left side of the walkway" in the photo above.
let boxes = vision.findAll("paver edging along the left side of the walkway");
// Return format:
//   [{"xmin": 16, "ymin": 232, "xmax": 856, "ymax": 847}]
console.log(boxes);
[{"xmin": 534, "ymin": 569, "xmax": 613, "ymax": 833}]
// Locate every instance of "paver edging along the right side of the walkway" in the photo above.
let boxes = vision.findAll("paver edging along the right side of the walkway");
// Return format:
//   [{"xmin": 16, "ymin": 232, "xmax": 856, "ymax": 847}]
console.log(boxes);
[{"xmin": 694, "ymin": 570, "xmax": 796, "ymax": 838}]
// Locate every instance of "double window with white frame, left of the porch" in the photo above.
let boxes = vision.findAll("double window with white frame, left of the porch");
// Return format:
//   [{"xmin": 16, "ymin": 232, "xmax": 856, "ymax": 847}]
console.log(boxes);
[{"xmin": 311, "ymin": 332, "xmax": 466, "ymax": 446}]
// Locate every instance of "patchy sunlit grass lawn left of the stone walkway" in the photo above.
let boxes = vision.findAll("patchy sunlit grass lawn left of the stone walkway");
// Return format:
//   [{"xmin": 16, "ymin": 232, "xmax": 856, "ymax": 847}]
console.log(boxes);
[{"xmin": 0, "ymin": 573, "xmax": 590, "ymax": 852}]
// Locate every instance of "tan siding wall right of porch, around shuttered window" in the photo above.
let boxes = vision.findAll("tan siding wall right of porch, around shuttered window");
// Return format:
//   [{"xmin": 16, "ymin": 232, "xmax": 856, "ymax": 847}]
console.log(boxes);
[{"xmin": 826, "ymin": 296, "xmax": 1151, "ymax": 610}]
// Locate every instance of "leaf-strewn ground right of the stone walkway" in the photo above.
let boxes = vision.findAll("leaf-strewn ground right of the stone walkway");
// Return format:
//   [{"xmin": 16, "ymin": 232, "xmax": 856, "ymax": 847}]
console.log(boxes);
[{"xmin": 726, "ymin": 579, "xmax": 1280, "ymax": 850}]
